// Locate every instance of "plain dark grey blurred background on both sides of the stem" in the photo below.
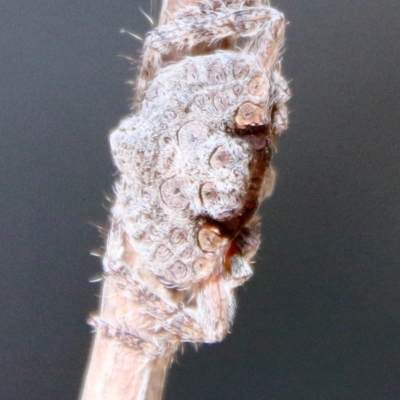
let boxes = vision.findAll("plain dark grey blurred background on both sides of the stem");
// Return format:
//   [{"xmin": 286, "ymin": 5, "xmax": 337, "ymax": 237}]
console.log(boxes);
[{"xmin": 0, "ymin": 0, "xmax": 400, "ymax": 400}]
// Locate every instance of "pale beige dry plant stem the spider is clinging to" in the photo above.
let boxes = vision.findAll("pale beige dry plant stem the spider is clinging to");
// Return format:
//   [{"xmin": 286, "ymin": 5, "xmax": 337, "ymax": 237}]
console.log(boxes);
[{"xmin": 80, "ymin": 0, "xmax": 209, "ymax": 400}]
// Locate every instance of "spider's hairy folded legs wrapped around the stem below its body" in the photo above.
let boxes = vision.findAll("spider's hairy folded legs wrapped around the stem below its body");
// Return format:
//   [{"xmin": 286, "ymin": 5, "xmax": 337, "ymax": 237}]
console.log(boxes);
[{"xmin": 89, "ymin": 273, "xmax": 235, "ymax": 346}]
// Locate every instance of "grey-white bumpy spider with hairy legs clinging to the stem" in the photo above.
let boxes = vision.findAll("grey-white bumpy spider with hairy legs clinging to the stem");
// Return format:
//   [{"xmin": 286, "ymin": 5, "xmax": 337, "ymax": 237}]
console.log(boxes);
[{"xmin": 92, "ymin": 0, "xmax": 290, "ymax": 357}]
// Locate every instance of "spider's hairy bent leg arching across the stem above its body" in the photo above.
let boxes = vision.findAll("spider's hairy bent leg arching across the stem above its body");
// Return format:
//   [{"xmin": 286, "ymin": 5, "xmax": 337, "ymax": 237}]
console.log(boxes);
[{"xmin": 136, "ymin": 1, "xmax": 285, "ymax": 104}]
